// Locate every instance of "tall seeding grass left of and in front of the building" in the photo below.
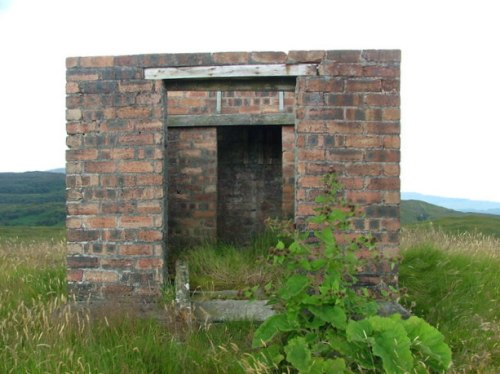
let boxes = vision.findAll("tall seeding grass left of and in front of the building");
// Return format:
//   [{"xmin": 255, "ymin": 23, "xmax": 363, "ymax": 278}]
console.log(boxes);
[{"xmin": 0, "ymin": 237, "xmax": 253, "ymax": 373}]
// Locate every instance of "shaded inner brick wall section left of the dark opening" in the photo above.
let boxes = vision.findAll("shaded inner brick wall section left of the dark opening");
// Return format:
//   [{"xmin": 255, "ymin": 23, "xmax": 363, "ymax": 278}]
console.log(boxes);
[{"xmin": 168, "ymin": 127, "xmax": 217, "ymax": 250}]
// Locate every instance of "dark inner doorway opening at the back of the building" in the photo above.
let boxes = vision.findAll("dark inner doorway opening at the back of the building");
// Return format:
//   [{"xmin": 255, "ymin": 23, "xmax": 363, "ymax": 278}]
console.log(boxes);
[{"xmin": 217, "ymin": 125, "xmax": 283, "ymax": 243}]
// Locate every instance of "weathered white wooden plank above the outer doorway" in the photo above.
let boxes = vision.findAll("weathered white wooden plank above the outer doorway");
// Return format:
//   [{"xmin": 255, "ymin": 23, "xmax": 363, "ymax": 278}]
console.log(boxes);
[{"xmin": 145, "ymin": 64, "xmax": 316, "ymax": 79}]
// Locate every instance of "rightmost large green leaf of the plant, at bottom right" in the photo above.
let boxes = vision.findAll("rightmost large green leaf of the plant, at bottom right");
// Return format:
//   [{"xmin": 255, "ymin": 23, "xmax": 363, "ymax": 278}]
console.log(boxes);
[{"xmin": 402, "ymin": 316, "xmax": 451, "ymax": 371}]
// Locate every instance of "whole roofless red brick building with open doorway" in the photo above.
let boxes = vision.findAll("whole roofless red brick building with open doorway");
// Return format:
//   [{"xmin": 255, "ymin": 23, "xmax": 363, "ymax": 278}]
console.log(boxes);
[{"xmin": 66, "ymin": 50, "xmax": 400, "ymax": 301}]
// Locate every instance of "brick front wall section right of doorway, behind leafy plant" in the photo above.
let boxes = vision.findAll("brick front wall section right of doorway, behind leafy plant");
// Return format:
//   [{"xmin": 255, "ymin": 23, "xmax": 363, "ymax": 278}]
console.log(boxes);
[{"xmin": 295, "ymin": 50, "xmax": 400, "ymax": 284}]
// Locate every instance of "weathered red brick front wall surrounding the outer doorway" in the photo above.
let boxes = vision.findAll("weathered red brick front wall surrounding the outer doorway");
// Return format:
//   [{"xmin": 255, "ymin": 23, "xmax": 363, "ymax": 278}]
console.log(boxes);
[{"xmin": 66, "ymin": 50, "xmax": 400, "ymax": 299}]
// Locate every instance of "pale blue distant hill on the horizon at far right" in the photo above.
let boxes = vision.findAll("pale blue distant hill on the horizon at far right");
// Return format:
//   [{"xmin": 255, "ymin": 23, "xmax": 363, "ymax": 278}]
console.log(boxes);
[{"xmin": 401, "ymin": 192, "xmax": 500, "ymax": 215}]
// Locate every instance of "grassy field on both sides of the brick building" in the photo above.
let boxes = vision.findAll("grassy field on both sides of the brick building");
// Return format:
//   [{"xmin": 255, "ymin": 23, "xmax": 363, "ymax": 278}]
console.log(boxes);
[{"xmin": 0, "ymin": 228, "xmax": 500, "ymax": 373}]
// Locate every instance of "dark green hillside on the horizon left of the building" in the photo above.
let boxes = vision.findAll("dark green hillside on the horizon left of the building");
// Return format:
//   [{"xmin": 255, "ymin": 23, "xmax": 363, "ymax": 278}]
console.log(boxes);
[{"xmin": 0, "ymin": 171, "xmax": 66, "ymax": 226}]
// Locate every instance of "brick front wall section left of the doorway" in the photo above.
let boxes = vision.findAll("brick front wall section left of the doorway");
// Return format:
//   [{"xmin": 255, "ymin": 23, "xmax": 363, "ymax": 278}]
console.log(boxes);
[{"xmin": 66, "ymin": 57, "xmax": 165, "ymax": 300}]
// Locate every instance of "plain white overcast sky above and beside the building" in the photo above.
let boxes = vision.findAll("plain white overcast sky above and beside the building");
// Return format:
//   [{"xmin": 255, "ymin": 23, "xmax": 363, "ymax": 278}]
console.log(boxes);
[{"xmin": 0, "ymin": 0, "xmax": 500, "ymax": 202}]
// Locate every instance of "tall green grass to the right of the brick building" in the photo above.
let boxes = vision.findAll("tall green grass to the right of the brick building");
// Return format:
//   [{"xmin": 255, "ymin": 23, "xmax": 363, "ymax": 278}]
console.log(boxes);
[{"xmin": 400, "ymin": 227, "xmax": 500, "ymax": 373}]
